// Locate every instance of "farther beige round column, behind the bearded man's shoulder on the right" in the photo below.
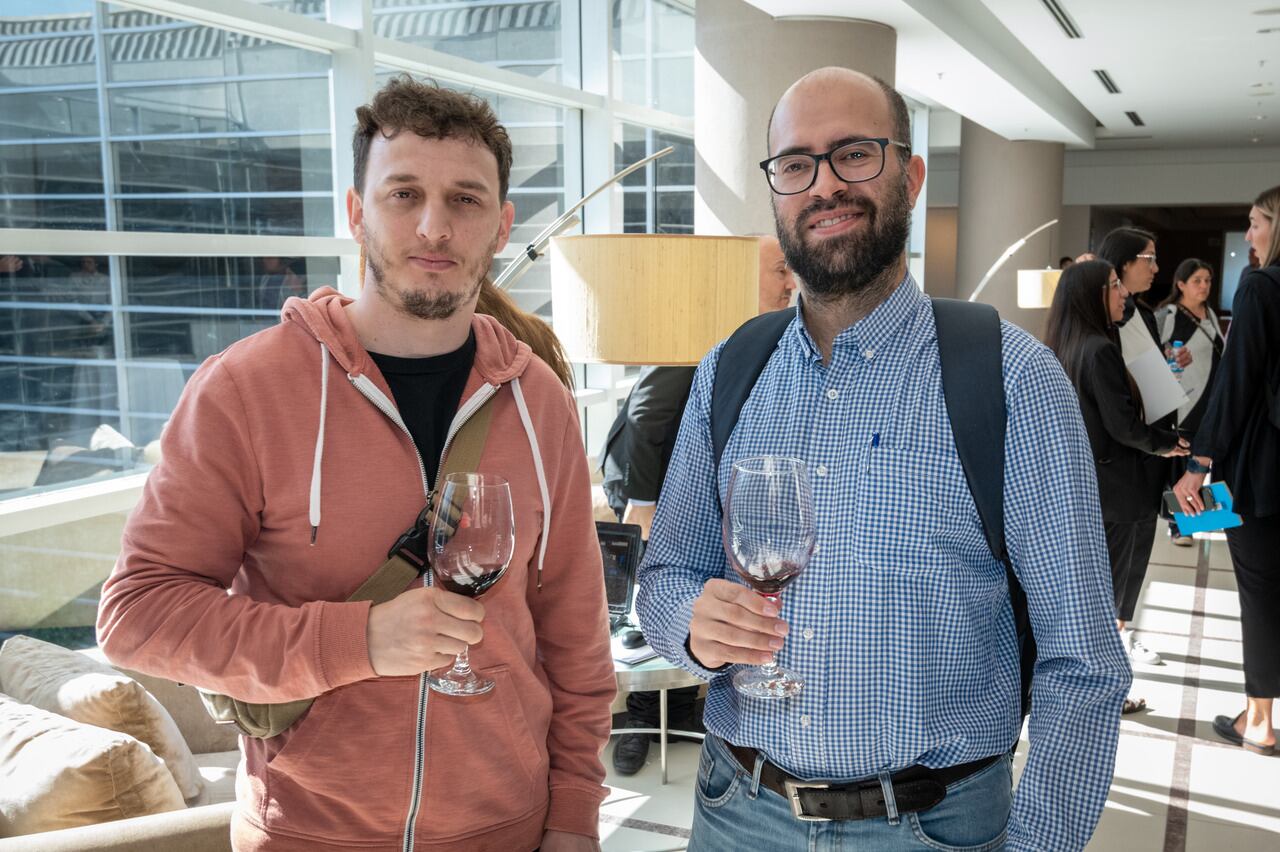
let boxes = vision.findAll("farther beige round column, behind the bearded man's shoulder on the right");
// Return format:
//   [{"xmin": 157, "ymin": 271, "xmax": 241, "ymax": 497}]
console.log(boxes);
[{"xmin": 956, "ymin": 119, "xmax": 1064, "ymax": 336}]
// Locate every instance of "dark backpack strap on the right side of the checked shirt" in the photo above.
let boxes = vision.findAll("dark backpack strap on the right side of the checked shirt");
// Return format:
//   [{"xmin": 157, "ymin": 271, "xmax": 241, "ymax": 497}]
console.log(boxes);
[{"xmin": 933, "ymin": 298, "xmax": 1036, "ymax": 716}]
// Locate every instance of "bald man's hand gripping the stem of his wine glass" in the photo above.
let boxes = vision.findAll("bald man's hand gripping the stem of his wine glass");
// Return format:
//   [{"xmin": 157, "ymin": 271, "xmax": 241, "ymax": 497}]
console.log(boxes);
[{"xmin": 689, "ymin": 580, "xmax": 788, "ymax": 669}]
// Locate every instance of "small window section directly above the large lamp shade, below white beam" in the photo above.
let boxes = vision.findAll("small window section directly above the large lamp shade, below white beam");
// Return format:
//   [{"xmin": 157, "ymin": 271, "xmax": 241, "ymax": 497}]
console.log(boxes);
[{"xmin": 614, "ymin": 123, "xmax": 694, "ymax": 234}]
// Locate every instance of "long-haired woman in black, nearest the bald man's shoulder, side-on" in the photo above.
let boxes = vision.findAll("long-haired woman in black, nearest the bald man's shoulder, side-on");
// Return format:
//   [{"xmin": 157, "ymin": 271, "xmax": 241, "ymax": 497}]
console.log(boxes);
[{"xmin": 1044, "ymin": 260, "xmax": 1187, "ymax": 713}]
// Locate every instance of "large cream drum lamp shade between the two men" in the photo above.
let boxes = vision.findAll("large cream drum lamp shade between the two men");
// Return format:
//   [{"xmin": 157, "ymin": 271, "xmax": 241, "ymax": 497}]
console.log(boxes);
[{"xmin": 552, "ymin": 234, "xmax": 760, "ymax": 366}]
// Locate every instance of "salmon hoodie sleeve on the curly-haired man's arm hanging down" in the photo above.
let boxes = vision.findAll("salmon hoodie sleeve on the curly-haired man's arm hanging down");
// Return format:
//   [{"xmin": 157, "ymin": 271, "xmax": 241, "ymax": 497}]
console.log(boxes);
[{"xmin": 529, "ymin": 388, "xmax": 617, "ymax": 846}]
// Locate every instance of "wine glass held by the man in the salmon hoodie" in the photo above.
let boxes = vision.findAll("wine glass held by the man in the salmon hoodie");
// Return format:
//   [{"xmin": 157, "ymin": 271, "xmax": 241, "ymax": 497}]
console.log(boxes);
[{"xmin": 426, "ymin": 473, "xmax": 516, "ymax": 695}]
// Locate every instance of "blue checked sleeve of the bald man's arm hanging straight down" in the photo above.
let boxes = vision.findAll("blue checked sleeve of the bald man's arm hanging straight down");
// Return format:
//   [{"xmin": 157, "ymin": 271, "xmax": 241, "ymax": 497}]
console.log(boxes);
[{"xmin": 1005, "ymin": 349, "xmax": 1133, "ymax": 852}]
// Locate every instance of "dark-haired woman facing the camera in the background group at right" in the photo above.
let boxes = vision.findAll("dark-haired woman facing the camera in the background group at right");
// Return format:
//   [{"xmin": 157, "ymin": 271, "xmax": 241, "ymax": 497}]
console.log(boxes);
[{"xmin": 1156, "ymin": 257, "xmax": 1222, "ymax": 548}]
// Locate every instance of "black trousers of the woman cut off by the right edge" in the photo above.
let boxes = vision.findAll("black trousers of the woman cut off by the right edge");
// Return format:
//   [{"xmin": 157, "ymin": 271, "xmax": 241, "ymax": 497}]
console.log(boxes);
[{"xmin": 1226, "ymin": 514, "xmax": 1280, "ymax": 698}]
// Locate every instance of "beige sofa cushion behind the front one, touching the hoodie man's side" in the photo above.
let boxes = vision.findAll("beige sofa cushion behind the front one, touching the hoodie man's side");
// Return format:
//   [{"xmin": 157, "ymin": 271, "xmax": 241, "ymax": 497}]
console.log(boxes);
[{"xmin": 0, "ymin": 636, "xmax": 202, "ymax": 798}]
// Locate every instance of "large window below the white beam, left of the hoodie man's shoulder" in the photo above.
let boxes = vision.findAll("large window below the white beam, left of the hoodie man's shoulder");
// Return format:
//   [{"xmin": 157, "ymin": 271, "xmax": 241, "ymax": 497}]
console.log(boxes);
[{"xmin": 0, "ymin": 255, "xmax": 338, "ymax": 496}]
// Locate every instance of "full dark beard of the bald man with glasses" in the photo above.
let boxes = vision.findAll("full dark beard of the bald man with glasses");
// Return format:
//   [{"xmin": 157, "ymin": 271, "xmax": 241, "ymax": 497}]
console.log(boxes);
[{"xmin": 773, "ymin": 167, "xmax": 911, "ymax": 299}]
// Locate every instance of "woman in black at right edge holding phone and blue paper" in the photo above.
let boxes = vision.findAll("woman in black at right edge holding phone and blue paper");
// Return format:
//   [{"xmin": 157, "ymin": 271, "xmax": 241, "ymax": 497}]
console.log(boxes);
[{"xmin": 1174, "ymin": 187, "xmax": 1280, "ymax": 755}]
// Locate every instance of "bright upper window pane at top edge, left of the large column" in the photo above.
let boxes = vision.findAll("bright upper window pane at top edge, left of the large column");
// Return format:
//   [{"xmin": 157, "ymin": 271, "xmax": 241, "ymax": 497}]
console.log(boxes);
[{"xmin": 612, "ymin": 0, "xmax": 694, "ymax": 115}]
